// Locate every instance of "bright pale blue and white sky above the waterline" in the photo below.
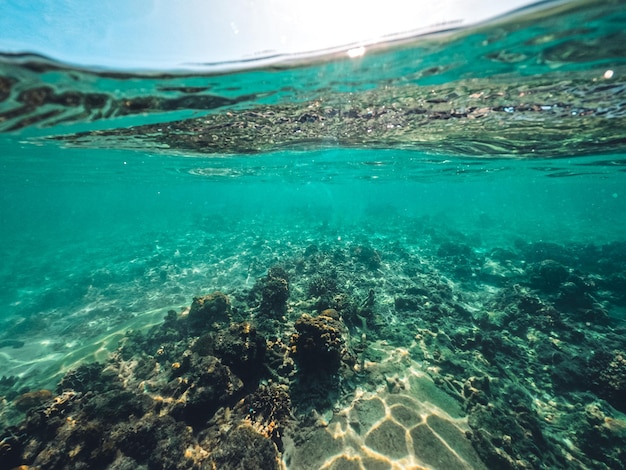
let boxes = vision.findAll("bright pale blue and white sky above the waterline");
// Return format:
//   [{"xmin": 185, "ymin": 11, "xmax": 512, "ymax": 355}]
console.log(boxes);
[{"xmin": 0, "ymin": 0, "xmax": 548, "ymax": 70}]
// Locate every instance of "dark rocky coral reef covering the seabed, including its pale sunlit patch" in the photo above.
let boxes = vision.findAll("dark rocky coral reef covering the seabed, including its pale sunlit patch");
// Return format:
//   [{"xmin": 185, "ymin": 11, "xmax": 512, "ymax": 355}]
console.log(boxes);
[{"xmin": 0, "ymin": 237, "xmax": 626, "ymax": 470}]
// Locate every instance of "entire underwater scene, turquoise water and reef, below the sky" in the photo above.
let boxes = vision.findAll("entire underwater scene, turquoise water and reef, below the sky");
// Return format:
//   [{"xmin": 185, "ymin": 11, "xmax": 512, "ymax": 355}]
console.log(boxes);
[{"xmin": 0, "ymin": 1, "xmax": 626, "ymax": 470}]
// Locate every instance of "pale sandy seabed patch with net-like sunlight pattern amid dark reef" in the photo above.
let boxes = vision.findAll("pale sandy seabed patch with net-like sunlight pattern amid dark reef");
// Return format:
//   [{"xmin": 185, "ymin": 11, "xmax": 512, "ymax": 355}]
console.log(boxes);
[{"xmin": 284, "ymin": 344, "xmax": 485, "ymax": 470}]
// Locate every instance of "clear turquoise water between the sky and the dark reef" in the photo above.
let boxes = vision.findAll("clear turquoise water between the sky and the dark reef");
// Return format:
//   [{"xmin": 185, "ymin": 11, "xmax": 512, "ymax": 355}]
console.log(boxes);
[{"xmin": 0, "ymin": 2, "xmax": 626, "ymax": 468}]
